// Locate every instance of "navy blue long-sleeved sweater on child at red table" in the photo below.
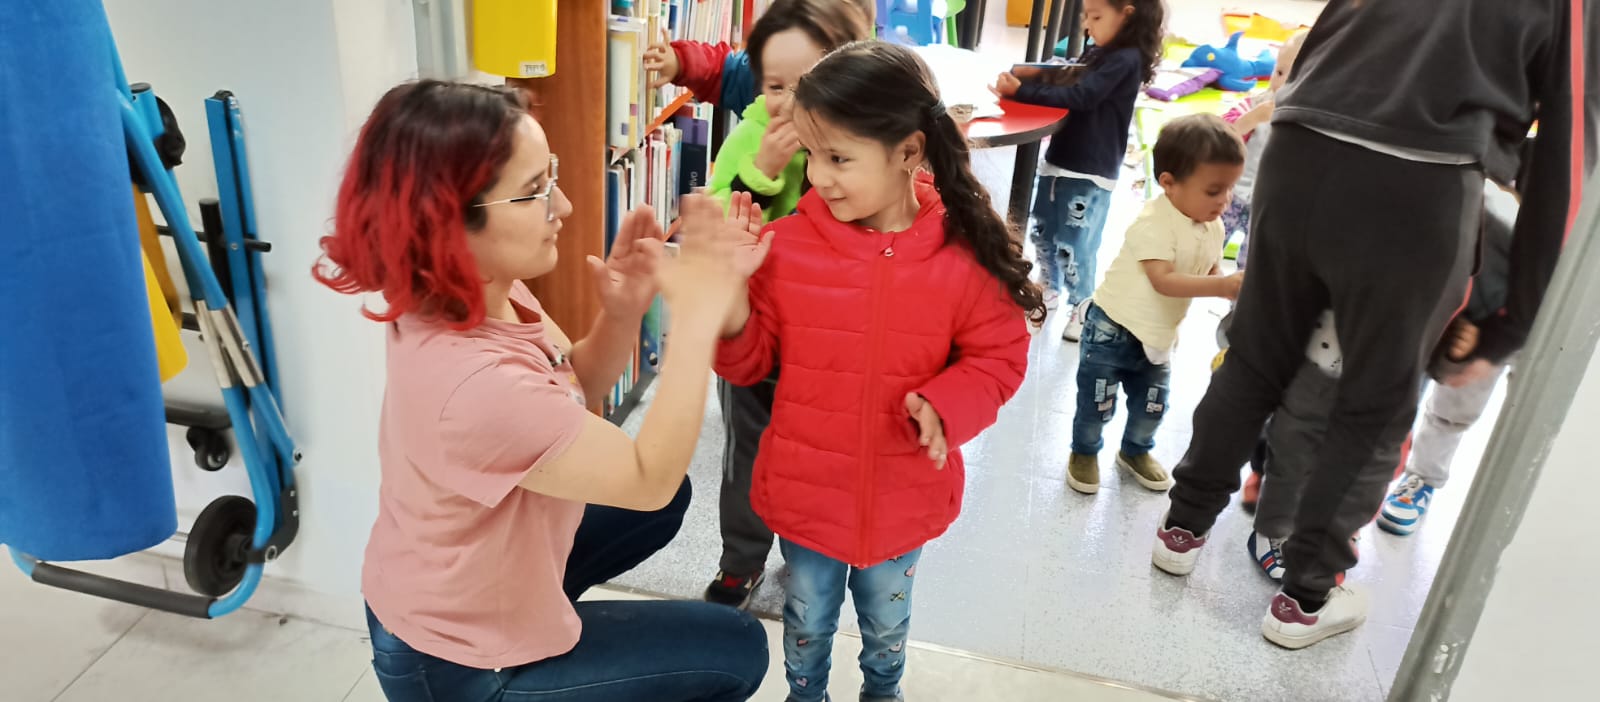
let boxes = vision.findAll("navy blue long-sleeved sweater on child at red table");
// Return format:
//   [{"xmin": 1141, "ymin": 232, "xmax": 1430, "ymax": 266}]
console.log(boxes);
[{"xmin": 1016, "ymin": 48, "xmax": 1144, "ymax": 181}]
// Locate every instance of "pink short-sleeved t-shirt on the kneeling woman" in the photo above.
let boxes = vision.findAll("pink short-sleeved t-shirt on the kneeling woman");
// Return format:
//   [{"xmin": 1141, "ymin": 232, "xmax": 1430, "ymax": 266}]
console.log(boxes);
[{"xmin": 362, "ymin": 283, "xmax": 587, "ymax": 668}]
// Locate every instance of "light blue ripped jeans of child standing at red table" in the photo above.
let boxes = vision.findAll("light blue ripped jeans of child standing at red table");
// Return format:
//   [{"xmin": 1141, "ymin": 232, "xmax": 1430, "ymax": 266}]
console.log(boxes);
[{"xmin": 1029, "ymin": 176, "xmax": 1110, "ymax": 305}]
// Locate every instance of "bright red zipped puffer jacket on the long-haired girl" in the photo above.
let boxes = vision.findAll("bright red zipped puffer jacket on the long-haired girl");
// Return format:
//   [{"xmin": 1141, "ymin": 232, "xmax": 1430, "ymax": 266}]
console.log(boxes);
[{"xmin": 717, "ymin": 177, "xmax": 1029, "ymax": 566}]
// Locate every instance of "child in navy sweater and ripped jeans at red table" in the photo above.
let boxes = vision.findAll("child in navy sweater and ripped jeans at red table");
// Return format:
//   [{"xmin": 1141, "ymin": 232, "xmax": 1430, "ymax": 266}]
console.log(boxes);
[{"xmin": 994, "ymin": 0, "xmax": 1165, "ymax": 341}]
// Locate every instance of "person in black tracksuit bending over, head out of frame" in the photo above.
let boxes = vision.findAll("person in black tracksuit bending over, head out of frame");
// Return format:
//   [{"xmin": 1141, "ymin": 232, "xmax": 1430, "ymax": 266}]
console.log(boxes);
[{"xmin": 1152, "ymin": 0, "xmax": 1592, "ymax": 648}]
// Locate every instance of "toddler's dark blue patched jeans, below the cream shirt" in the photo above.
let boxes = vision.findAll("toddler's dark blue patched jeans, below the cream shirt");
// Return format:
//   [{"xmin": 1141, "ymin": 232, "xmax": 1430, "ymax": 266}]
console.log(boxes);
[{"xmin": 1072, "ymin": 304, "xmax": 1171, "ymax": 457}]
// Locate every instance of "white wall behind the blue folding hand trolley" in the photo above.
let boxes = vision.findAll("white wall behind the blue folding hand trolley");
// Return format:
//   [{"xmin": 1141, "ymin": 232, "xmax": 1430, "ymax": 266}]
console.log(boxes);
[{"xmin": 106, "ymin": 0, "xmax": 416, "ymax": 604}]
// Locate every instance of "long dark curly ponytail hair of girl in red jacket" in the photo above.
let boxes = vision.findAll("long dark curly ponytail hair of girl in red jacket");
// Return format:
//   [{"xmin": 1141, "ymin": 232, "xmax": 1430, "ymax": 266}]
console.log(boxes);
[{"xmin": 794, "ymin": 42, "xmax": 1045, "ymax": 323}]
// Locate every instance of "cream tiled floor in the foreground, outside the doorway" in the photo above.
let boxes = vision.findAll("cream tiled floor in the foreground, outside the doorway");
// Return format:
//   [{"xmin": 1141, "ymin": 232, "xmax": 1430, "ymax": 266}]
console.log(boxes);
[{"xmin": 0, "ymin": 555, "xmax": 1173, "ymax": 702}]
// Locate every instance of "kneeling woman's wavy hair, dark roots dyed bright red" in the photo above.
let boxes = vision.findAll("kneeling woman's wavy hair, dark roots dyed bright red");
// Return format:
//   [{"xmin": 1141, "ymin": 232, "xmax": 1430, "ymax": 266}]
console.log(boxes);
[{"xmin": 312, "ymin": 80, "xmax": 528, "ymax": 329}]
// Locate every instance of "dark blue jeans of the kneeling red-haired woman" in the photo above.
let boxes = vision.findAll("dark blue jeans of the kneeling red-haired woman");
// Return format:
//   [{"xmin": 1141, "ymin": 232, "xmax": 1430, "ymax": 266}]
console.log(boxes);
[{"xmin": 366, "ymin": 480, "xmax": 768, "ymax": 702}]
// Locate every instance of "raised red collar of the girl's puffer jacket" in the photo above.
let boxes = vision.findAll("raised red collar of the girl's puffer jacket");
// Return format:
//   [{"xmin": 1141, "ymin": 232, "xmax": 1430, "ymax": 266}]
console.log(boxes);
[{"xmin": 797, "ymin": 173, "xmax": 944, "ymax": 261}]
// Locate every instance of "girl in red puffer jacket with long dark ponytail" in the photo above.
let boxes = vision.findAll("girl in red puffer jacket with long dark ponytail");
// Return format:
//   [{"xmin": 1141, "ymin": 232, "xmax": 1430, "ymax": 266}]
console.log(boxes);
[{"xmin": 717, "ymin": 42, "xmax": 1045, "ymax": 702}]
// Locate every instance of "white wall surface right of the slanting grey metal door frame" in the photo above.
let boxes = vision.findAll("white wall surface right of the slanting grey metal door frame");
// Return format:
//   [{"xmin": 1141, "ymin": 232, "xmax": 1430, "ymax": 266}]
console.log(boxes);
[{"xmin": 1451, "ymin": 353, "xmax": 1600, "ymax": 702}]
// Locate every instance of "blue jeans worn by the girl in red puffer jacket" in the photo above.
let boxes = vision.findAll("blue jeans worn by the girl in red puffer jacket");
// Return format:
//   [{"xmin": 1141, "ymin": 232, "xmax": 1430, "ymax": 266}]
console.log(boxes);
[{"xmin": 778, "ymin": 539, "xmax": 922, "ymax": 702}]
